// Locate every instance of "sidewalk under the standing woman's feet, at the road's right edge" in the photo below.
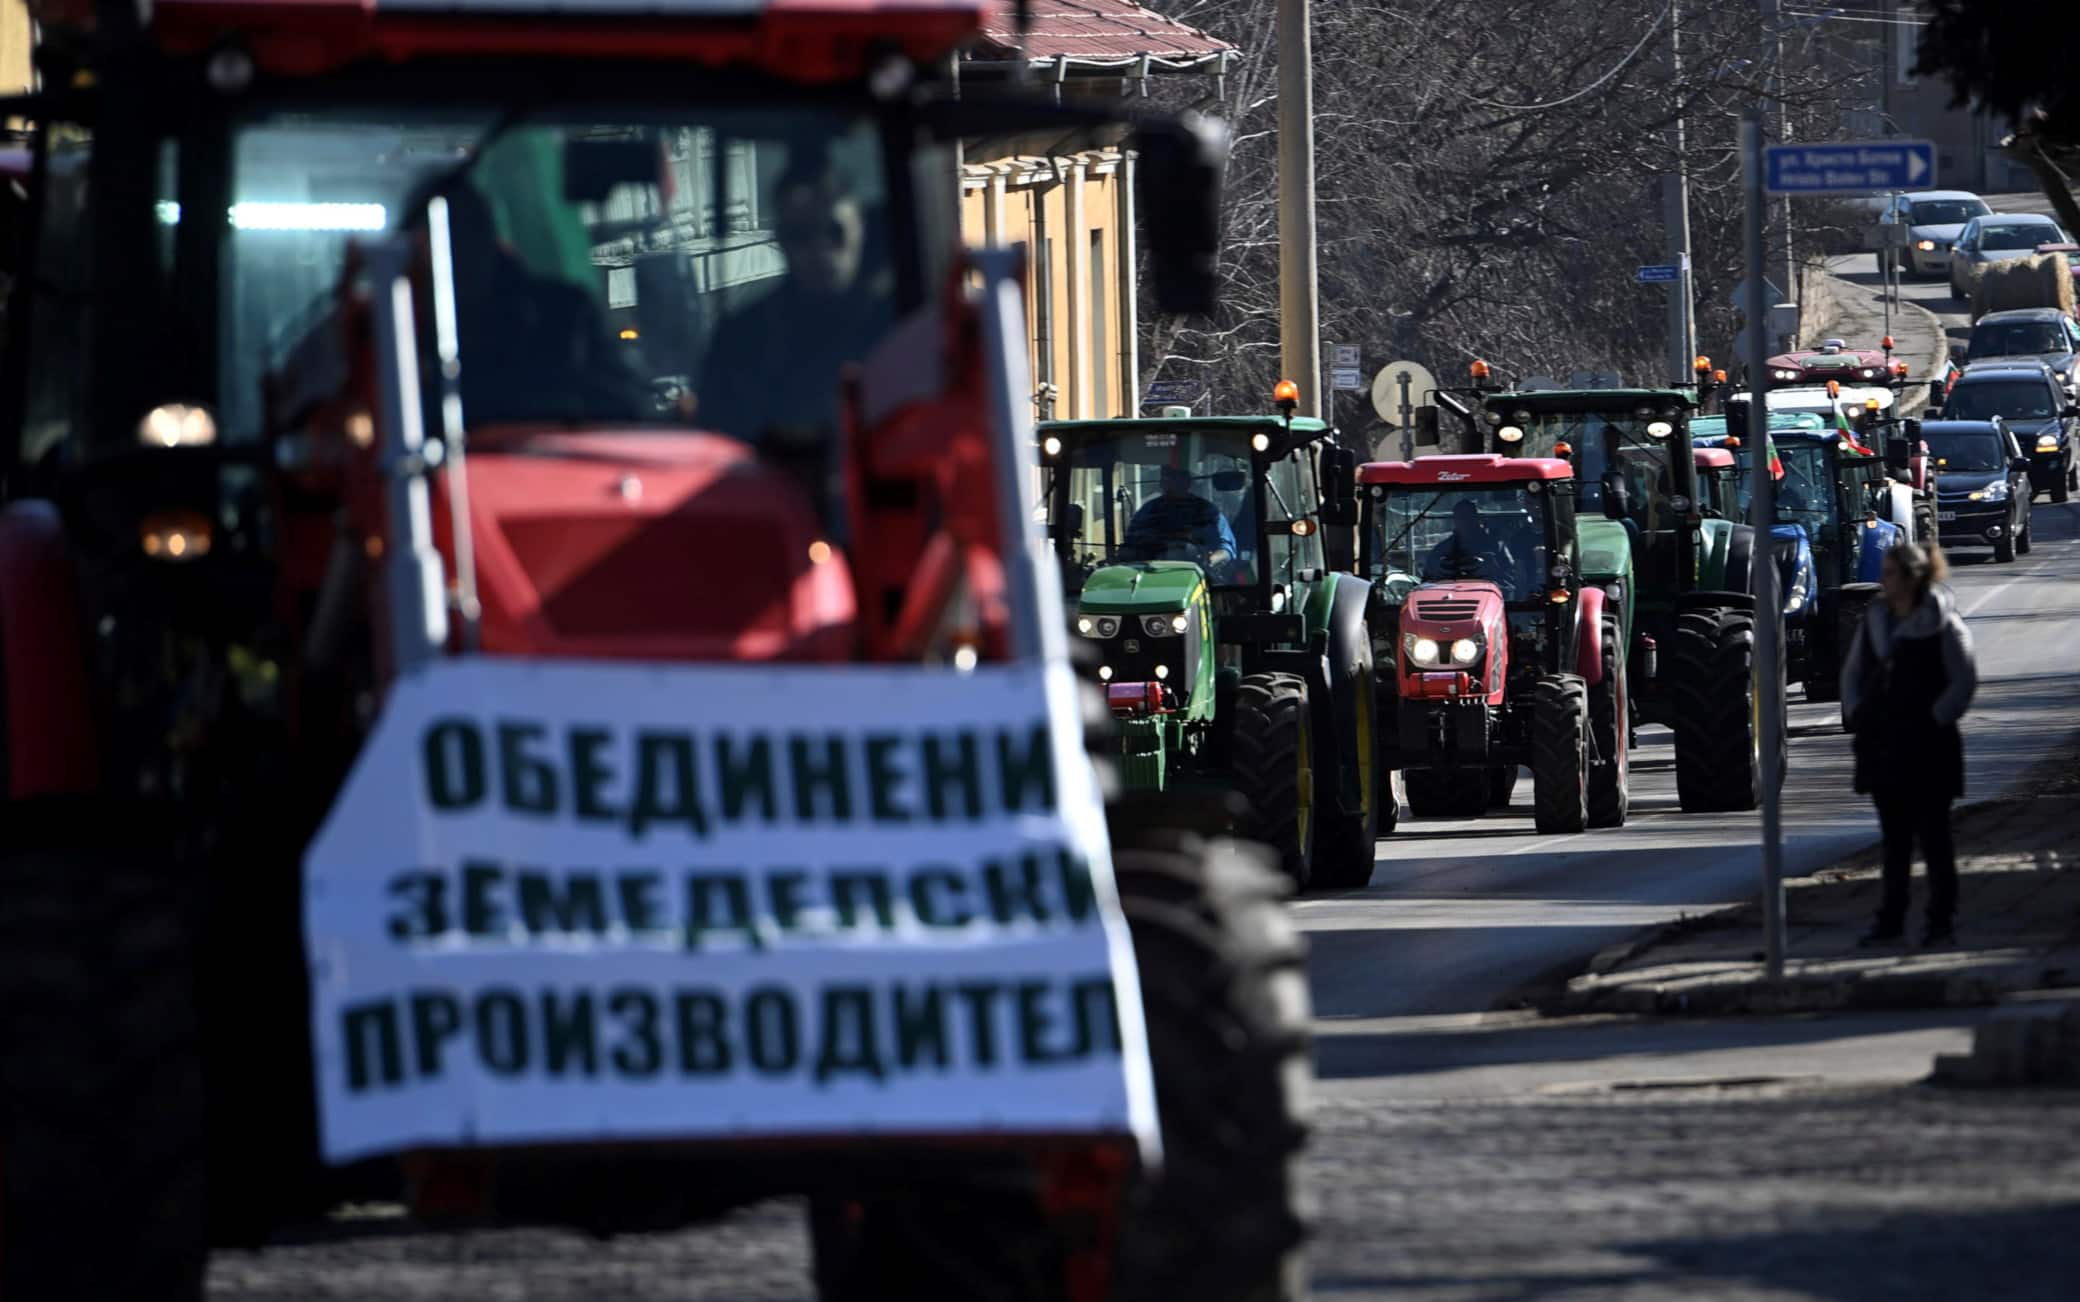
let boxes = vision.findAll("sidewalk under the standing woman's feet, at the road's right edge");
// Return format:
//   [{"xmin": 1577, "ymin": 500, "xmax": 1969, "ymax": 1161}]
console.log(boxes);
[{"xmin": 1541, "ymin": 761, "xmax": 2080, "ymax": 1015}]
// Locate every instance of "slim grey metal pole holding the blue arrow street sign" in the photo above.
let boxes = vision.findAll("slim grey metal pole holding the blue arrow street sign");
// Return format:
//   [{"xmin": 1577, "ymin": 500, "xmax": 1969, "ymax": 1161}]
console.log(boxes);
[{"xmin": 1741, "ymin": 108, "xmax": 1785, "ymax": 982}]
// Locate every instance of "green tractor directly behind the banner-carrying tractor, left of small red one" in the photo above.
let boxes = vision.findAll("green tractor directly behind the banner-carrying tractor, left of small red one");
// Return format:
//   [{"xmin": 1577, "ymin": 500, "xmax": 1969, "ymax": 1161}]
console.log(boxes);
[{"xmin": 1038, "ymin": 385, "xmax": 1398, "ymax": 888}]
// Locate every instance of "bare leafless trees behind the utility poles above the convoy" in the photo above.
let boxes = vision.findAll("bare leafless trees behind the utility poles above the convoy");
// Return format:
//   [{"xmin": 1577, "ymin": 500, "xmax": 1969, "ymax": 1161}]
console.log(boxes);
[{"xmin": 1144, "ymin": 0, "xmax": 1860, "ymax": 420}]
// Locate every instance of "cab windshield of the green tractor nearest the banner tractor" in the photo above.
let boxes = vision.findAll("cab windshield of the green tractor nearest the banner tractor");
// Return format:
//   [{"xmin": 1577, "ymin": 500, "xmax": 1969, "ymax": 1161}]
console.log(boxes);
[{"xmin": 1048, "ymin": 426, "xmax": 1319, "ymax": 587}]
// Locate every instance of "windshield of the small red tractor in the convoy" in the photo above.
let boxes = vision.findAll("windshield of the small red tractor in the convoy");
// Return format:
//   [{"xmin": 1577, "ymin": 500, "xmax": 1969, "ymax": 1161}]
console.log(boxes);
[{"xmin": 1369, "ymin": 485, "xmax": 1552, "ymax": 601}]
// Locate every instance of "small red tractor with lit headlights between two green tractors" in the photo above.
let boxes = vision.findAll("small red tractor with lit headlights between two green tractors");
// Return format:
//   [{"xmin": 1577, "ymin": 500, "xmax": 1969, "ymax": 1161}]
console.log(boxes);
[{"xmin": 1358, "ymin": 455, "xmax": 1631, "ymax": 832}]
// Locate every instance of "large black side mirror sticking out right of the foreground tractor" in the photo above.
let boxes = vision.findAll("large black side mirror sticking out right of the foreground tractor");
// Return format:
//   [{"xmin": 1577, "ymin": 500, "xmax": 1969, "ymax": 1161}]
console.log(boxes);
[{"xmin": 1134, "ymin": 112, "xmax": 1227, "ymax": 314}]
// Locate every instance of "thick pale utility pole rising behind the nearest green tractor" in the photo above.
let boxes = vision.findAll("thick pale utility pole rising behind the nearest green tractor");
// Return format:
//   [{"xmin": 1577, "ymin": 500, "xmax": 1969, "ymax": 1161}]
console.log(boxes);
[{"xmin": 1279, "ymin": 0, "xmax": 1323, "ymax": 416}]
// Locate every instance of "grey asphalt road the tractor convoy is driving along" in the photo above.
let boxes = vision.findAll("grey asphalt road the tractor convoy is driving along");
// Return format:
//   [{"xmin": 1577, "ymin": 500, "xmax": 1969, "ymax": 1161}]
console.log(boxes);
[{"xmin": 1298, "ymin": 241, "xmax": 2080, "ymax": 1098}]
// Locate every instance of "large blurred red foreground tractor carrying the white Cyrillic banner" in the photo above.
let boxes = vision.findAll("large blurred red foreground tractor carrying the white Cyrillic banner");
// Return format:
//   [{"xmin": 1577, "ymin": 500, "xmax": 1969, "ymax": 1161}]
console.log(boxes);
[{"xmin": 0, "ymin": 0, "xmax": 1308, "ymax": 1302}]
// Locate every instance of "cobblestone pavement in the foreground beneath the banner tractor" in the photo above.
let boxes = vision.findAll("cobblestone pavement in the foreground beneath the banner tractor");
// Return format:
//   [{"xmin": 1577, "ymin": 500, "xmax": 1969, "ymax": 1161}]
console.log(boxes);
[{"xmin": 210, "ymin": 1086, "xmax": 2080, "ymax": 1302}]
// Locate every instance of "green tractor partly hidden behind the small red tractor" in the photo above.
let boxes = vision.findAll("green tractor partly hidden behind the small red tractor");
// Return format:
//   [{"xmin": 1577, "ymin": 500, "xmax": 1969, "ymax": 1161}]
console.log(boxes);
[{"xmin": 1481, "ymin": 380, "xmax": 1783, "ymax": 811}]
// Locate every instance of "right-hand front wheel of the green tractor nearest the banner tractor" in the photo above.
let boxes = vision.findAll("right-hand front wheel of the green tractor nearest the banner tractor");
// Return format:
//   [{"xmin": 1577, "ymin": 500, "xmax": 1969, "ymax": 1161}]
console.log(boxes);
[{"xmin": 1231, "ymin": 674, "xmax": 1315, "ymax": 890}]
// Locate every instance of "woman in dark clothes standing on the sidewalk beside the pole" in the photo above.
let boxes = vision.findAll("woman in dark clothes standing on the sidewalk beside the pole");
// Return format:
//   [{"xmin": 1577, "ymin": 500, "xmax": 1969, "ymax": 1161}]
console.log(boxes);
[{"xmin": 1841, "ymin": 543, "xmax": 1978, "ymax": 944}]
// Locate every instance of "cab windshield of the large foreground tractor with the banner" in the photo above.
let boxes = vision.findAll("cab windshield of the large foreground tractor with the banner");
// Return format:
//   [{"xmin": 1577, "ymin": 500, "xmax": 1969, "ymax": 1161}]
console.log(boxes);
[{"xmin": 223, "ymin": 106, "xmax": 894, "ymax": 447}]
